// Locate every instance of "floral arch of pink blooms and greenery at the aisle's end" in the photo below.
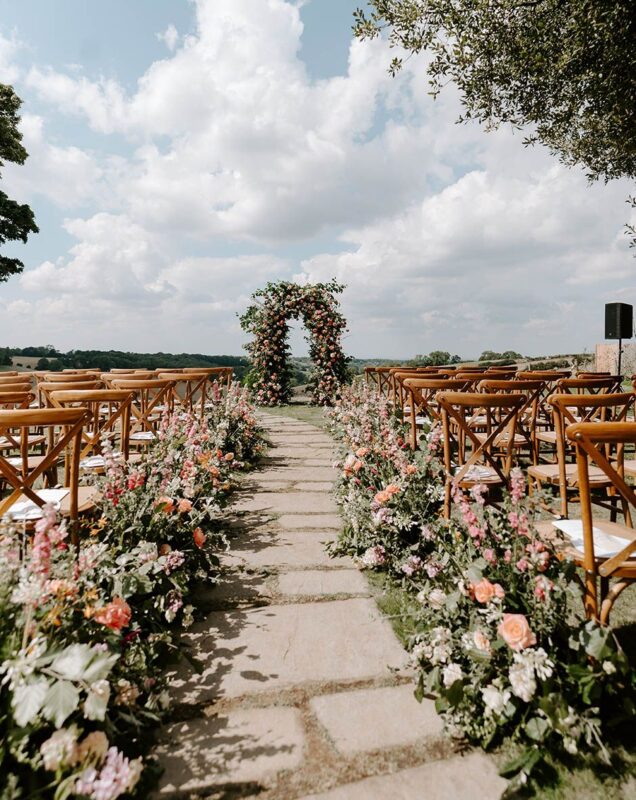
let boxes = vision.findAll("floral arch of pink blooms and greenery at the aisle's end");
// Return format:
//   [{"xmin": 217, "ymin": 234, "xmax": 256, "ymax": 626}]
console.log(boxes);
[{"xmin": 241, "ymin": 280, "xmax": 347, "ymax": 406}]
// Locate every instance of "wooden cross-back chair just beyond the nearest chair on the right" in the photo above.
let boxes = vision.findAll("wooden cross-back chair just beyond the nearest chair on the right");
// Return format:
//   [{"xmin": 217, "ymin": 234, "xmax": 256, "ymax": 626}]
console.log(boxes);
[{"xmin": 528, "ymin": 392, "xmax": 634, "ymax": 517}]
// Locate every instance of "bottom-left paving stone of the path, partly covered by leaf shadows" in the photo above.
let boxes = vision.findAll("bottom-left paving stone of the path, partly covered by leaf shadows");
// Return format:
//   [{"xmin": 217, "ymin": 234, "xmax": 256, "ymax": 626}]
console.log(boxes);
[{"xmin": 155, "ymin": 708, "xmax": 304, "ymax": 797}]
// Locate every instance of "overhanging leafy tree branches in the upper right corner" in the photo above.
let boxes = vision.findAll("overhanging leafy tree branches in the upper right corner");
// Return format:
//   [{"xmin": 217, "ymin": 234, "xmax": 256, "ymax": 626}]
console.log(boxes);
[{"xmin": 354, "ymin": 0, "xmax": 636, "ymax": 180}]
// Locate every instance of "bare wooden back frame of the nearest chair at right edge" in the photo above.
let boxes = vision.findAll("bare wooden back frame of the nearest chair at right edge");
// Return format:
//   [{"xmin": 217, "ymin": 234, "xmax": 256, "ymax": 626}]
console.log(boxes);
[{"xmin": 566, "ymin": 422, "xmax": 636, "ymax": 622}]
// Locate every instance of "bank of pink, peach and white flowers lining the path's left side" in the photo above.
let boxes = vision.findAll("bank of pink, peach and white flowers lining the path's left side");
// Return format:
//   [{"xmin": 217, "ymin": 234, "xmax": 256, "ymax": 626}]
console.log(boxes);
[{"xmin": 0, "ymin": 388, "xmax": 262, "ymax": 800}]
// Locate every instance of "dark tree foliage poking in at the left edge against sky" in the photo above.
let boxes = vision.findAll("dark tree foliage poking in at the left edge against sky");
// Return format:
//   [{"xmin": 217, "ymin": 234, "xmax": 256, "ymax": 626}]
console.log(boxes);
[{"xmin": 0, "ymin": 84, "xmax": 39, "ymax": 282}]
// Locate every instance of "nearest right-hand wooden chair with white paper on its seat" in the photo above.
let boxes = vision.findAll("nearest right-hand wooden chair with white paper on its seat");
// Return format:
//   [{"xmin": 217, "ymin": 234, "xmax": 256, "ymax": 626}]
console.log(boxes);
[{"xmin": 566, "ymin": 422, "xmax": 636, "ymax": 623}]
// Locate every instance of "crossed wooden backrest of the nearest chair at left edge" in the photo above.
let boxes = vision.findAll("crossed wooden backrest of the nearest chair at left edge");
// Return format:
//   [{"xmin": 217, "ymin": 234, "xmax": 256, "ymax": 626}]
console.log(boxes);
[{"xmin": 0, "ymin": 408, "xmax": 86, "ymax": 541}]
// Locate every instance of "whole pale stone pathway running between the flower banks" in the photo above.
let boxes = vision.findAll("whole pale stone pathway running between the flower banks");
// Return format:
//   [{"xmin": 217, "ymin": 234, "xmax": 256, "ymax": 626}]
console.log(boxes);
[{"xmin": 157, "ymin": 414, "xmax": 505, "ymax": 800}]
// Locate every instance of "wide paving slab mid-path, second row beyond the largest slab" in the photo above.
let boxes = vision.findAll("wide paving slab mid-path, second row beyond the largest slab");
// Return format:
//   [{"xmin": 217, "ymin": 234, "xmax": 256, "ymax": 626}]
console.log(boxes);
[{"xmin": 221, "ymin": 531, "xmax": 353, "ymax": 570}]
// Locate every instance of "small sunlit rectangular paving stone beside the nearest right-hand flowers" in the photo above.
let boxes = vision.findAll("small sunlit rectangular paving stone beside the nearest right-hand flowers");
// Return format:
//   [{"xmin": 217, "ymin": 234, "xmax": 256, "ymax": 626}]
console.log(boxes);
[{"xmin": 310, "ymin": 684, "xmax": 443, "ymax": 755}]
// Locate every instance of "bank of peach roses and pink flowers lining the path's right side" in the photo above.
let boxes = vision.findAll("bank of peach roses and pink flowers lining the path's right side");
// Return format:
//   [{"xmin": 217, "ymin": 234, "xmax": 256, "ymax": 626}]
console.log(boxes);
[{"xmin": 330, "ymin": 385, "xmax": 636, "ymax": 782}]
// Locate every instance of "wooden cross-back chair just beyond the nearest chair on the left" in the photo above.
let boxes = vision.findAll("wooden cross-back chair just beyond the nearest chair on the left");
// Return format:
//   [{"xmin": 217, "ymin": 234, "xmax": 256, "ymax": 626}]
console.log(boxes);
[{"xmin": 50, "ymin": 389, "xmax": 133, "ymax": 472}]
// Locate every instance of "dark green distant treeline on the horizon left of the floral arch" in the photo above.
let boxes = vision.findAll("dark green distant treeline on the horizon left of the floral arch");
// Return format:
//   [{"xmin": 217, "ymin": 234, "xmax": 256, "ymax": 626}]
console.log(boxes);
[{"xmin": 0, "ymin": 346, "xmax": 249, "ymax": 378}]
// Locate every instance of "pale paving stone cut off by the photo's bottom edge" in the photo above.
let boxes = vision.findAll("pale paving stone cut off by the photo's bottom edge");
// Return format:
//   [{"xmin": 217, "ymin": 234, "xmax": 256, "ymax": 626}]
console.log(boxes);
[{"xmin": 301, "ymin": 753, "xmax": 506, "ymax": 800}]
